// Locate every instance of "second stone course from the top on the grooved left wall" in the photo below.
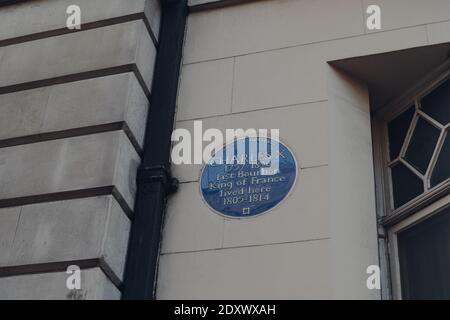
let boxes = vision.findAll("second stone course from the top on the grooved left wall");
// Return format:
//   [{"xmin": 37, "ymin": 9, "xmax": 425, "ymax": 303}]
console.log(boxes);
[{"xmin": 0, "ymin": 20, "xmax": 156, "ymax": 90}]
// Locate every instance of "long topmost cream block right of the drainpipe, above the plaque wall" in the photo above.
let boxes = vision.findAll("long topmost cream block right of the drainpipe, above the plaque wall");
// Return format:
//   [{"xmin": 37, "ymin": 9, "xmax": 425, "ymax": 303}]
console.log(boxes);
[{"xmin": 183, "ymin": 0, "xmax": 365, "ymax": 63}]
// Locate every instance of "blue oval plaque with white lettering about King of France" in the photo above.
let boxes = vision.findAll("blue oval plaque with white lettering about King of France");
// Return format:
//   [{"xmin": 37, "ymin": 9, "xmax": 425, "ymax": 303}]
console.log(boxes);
[{"xmin": 200, "ymin": 137, "xmax": 297, "ymax": 218}]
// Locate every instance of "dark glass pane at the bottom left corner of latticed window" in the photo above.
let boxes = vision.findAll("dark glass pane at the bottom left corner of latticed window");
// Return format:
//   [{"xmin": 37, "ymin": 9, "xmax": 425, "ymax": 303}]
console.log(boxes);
[{"xmin": 391, "ymin": 163, "xmax": 423, "ymax": 208}]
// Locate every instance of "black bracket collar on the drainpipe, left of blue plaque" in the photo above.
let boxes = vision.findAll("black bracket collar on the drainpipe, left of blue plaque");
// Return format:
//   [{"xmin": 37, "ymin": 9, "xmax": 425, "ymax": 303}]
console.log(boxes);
[{"xmin": 136, "ymin": 165, "xmax": 180, "ymax": 195}]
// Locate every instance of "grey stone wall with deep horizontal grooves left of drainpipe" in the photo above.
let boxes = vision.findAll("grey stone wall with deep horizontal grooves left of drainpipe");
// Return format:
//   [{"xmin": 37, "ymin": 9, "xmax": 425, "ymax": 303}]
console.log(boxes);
[{"xmin": 0, "ymin": 0, "xmax": 160, "ymax": 299}]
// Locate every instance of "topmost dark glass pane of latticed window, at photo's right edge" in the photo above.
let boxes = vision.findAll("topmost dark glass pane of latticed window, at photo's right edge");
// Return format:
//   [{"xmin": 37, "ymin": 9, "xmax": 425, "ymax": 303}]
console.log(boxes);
[{"xmin": 422, "ymin": 78, "xmax": 450, "ymax": 125}]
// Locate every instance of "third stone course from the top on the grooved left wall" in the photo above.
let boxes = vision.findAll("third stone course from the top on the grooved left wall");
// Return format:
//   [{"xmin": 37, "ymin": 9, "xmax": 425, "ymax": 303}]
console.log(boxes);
[{"xmin": 0, "ymin": 73, "xmax": 149, "ymax": 147}]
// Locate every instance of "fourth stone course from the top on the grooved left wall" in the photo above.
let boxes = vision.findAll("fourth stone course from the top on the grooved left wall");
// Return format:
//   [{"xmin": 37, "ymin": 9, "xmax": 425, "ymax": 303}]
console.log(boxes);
[{"xmin": 0, "ymin": 131, "xmax": 140, "ymax": 208}]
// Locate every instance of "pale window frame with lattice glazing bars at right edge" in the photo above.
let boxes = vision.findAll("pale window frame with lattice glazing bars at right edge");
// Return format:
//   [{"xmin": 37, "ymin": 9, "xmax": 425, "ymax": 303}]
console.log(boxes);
[{"xmin": 372, "ymin": 57, "xmax": 450, "ymax": 299}]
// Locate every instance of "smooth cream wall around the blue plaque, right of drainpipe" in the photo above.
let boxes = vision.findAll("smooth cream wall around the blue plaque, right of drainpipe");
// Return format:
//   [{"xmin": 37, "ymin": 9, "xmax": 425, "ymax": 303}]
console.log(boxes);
[{"xmin": 157, "ymin": 0, "xmax": 450, "ymax": 299}]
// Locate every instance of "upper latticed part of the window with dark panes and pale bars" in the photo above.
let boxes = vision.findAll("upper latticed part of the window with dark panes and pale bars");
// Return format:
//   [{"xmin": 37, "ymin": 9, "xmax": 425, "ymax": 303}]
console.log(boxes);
[{"xmin": 387, "ymin": 78, "xmax": 450, "ymax": 209}]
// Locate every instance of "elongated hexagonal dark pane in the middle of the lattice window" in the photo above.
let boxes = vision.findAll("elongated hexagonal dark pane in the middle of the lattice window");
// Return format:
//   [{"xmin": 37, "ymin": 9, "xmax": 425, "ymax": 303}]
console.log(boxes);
[{"xmin": 405, "ymin": 118, "xmax": 440, "ymax": 174}]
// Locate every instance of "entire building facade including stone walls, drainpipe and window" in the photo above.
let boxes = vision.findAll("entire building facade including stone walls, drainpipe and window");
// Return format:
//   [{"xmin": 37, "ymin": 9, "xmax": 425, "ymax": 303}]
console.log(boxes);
[{"xmin": 0, "ymin": 0, "xmax": 450, "ymax": 299}]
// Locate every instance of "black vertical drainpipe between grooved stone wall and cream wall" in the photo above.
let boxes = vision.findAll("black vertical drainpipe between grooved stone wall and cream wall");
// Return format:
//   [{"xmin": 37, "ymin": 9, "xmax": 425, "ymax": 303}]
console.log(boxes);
[{"xmin": 122, "ymin": 0, "xmax": 188, "ymax": 300}]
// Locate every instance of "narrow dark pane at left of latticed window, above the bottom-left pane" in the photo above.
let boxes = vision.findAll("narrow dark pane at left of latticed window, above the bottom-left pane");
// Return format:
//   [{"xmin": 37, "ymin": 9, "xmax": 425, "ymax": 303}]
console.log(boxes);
[{"xmin": 388, "ymin": 107, "xmax": 415, "ymax": 160}]
